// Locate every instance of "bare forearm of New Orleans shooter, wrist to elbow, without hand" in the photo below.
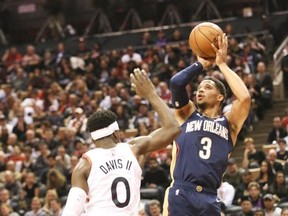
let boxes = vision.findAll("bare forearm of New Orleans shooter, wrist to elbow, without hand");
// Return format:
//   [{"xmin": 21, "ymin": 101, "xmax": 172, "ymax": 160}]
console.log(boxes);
[{"xmin": 218, "ymin": 63, "xmax": 251, "ymax": 103}]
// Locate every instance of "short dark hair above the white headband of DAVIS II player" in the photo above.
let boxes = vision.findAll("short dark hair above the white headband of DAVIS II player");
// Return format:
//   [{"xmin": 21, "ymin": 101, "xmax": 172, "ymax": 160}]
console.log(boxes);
[{"xmin": 87, "ymin": 110, "xmax": 117, "ymax": 132}]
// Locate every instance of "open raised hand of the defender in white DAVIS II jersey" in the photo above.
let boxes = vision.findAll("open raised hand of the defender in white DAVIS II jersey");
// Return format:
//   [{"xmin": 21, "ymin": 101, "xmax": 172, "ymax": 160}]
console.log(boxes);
[{"xmin": 130, "ymin": 68, "xmax": 157, "ymax": 99}]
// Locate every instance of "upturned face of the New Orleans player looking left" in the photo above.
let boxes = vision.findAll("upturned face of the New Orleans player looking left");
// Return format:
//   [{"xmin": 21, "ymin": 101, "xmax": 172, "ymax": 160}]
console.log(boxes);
[{"xmin": 196, "ymin": 80, "xmax": 219, "ymax": 107}]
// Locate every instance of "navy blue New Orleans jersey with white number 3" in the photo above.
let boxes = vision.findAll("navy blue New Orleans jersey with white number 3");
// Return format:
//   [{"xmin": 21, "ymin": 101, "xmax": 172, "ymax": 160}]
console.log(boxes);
[{"xmin": 171, "ymin": 111, "xmax": 233, "ymax": 190}]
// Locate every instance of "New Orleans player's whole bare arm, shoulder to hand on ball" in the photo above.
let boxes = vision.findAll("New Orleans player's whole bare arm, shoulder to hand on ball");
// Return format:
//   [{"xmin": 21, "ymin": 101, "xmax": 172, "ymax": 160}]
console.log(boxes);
[{"xmin": 212, "ymin": 34, "xmax": 251, "ymax": 144}]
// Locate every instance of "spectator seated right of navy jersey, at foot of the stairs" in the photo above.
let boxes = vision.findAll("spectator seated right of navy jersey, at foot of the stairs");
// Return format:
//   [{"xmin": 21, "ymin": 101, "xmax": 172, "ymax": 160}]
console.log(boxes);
[{"xmin": 242, "ymin": 137, "xmax": 266, "ymax": 168}]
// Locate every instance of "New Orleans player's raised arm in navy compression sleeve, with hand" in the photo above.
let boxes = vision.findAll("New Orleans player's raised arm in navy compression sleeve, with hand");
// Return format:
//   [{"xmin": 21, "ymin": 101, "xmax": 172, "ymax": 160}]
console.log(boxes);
[{"xmin": 170, "ymin": 56, "xmax": 212, "ymax": 124}]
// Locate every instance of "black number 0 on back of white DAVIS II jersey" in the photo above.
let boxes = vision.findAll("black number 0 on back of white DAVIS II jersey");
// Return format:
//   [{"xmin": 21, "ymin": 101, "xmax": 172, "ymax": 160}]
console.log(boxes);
[{"xmin": 111, "ymin": 177, "xmax": 131, "ymax": 208}]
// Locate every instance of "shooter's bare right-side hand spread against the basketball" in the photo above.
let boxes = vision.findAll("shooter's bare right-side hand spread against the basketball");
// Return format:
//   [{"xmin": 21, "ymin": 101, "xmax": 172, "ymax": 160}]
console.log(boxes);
[{"xmin": 211, "ymin": 33, "xmax": 228, "ymax": 66}]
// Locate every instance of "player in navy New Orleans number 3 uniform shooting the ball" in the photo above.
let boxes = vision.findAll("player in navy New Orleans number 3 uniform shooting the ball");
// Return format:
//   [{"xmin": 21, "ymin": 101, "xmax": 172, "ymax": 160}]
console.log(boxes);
[{"xmin": 163, "ymin": 34, "xmax": 251, "ymax": 216}]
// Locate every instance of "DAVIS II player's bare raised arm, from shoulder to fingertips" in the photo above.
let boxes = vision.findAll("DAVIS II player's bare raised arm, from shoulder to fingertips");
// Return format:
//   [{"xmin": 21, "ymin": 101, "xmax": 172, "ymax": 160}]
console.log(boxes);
[{"xmin": 129, "ymin": 68, "xmax": 181, "ymax": 155}]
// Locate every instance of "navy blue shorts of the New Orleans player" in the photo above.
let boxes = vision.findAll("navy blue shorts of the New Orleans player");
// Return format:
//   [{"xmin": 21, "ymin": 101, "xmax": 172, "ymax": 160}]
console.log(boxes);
[{"xmin": 168, "ymin": 182, "xmax": 221, "ymax": 216}]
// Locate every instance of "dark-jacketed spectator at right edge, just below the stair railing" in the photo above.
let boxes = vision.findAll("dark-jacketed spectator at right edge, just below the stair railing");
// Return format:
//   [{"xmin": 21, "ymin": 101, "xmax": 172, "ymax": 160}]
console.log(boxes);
[{"xmin": 267, "ymin": 116, "xmax": 288, "ymax": 144}]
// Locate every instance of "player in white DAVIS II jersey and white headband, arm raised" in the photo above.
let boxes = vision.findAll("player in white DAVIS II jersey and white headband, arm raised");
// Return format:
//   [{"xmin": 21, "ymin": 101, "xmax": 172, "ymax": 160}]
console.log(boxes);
[{"xmin": 62, "ymin": 69, "xmax": 181, "ymax": 216}]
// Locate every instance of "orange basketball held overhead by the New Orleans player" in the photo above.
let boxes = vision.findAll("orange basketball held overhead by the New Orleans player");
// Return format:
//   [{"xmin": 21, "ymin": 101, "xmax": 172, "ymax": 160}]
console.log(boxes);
[{"xmin": 189, "ymin": 22, "xmax": 223, "ymax": 59}]
